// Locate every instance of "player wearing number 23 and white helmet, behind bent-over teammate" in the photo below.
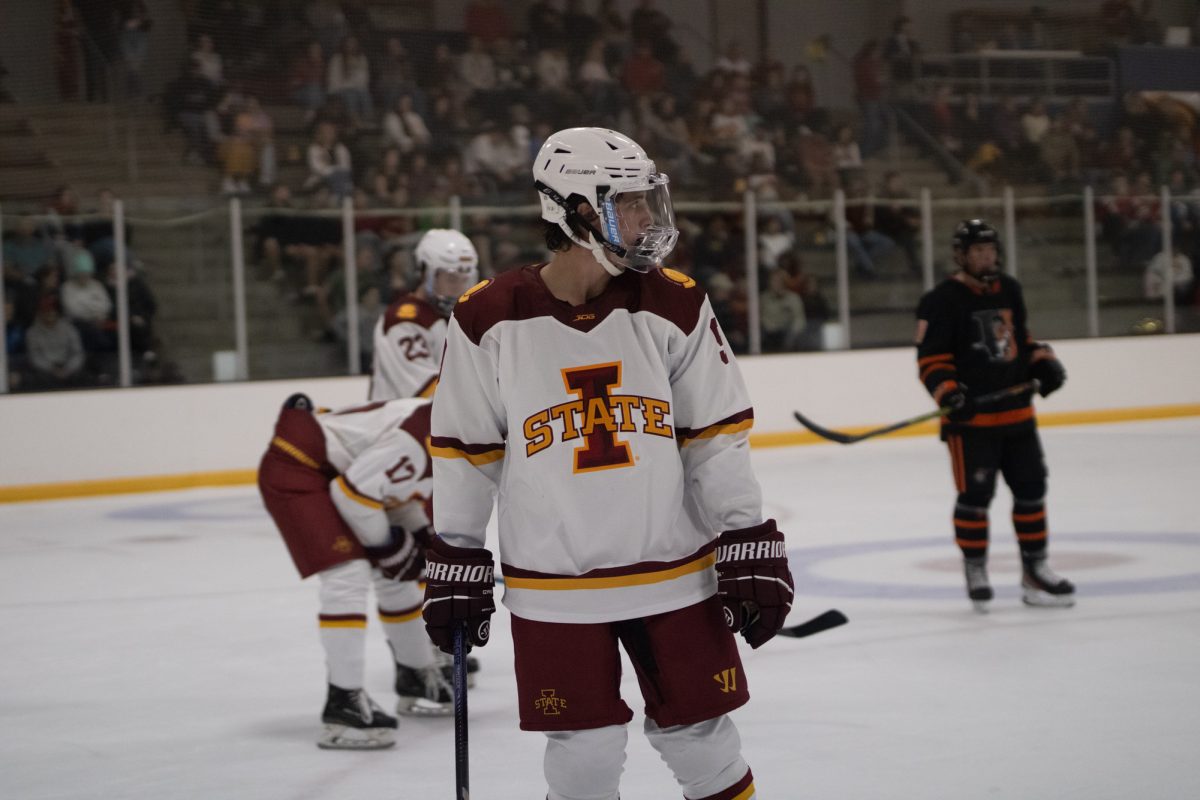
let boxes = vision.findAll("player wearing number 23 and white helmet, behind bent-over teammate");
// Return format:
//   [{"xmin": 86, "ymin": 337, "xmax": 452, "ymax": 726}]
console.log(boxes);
[{"xmin": 370, "ymin": 229, "xmax": 479, "ymax": 401}]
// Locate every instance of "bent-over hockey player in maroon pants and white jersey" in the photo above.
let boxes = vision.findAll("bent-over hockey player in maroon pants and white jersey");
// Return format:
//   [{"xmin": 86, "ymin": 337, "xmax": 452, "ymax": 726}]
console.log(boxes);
[{"xmin": 258, "ymin": 395, "xmax": 452, "ymax": 750}]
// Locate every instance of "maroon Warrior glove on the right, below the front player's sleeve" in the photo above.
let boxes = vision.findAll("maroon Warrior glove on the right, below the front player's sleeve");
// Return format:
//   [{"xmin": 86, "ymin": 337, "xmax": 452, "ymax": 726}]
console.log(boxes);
[{"xmin": 716, "ymin": 519, "xmax": 794, "ymax": 648}]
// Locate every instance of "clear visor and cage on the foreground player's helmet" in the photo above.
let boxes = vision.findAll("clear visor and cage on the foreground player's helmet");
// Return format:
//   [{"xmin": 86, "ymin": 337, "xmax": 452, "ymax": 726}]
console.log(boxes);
[{"xmin": 600, "ymin": 173, "xmax": 679, "ymax": 272}]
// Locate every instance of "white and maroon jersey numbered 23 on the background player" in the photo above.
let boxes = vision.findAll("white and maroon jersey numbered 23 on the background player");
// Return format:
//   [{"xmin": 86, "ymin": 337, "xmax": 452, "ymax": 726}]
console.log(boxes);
[{"xmin": 370, "ymin": 294, "xmax": 446, "ymax": 401}]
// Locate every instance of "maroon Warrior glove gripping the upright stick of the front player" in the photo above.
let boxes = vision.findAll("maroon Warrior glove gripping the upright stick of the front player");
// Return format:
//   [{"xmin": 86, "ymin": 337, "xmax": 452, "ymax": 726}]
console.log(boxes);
[{"xmin": 422, "ymin": 536, "xmax": 496, "ymax": 654}]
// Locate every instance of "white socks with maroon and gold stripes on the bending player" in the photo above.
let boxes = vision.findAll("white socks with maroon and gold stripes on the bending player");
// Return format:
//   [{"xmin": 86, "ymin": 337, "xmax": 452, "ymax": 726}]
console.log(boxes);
[{"xmin": 317, "ymin": 559, "xmax": 434, "ymax": 688}]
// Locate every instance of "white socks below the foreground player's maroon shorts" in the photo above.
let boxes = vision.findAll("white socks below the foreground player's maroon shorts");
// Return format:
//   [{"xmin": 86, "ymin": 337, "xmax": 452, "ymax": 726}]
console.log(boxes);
[{"xmin": 545, "ymin": 715, "xmax": 749, "ymax": 800}]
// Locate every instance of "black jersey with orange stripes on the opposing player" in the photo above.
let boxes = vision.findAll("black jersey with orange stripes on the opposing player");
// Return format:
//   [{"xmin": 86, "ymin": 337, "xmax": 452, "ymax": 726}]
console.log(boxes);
[{"xmin": 916, "ymin": 272, "xmax": 1040, "ymax": 434}]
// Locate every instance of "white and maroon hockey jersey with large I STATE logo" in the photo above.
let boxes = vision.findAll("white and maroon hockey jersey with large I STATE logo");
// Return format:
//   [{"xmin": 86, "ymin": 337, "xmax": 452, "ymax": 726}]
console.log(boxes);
[{"xmin": 431, "ymin": 265, "xmax": 762, "ymax": 622}]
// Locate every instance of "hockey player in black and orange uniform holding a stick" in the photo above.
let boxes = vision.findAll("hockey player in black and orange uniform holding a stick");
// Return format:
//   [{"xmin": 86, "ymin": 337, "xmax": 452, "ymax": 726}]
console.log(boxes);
[{"xmin": 917, "ymin": 219, "xmax": 1075, "ymax": 612}]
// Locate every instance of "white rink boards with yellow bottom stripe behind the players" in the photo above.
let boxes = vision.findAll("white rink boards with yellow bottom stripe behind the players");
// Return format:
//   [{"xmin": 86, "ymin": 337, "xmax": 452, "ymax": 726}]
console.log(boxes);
[{"xmin": 0, "ymin": 335, "xmax": 1200, "ymax": 501}]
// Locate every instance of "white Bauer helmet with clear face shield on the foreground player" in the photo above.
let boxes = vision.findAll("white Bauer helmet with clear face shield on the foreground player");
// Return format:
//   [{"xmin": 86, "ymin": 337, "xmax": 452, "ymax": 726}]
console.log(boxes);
[{"xmin": 533, "ymin": 128, "xmax": 679, "ymax": 276}]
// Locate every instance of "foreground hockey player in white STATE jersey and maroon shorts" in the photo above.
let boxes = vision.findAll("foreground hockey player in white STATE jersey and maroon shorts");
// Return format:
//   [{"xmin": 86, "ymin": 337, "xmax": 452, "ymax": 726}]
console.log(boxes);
[{"xmin": 425, "ymin": 128, "xmax": 792, "ymax": 800}]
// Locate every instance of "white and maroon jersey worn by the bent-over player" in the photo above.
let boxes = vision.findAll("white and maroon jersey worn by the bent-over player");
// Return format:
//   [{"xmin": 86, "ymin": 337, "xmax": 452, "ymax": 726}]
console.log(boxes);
[{"xmin": 316, "ymin": 398, "xmax": 433, "ymax": 547}]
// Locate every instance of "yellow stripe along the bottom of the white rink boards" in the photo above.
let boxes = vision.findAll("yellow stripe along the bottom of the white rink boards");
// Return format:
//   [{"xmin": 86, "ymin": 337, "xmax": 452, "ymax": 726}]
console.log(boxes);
[{"xmin": 0, "ymin": 403, "xmax": 1200, "ymax": 503}]
